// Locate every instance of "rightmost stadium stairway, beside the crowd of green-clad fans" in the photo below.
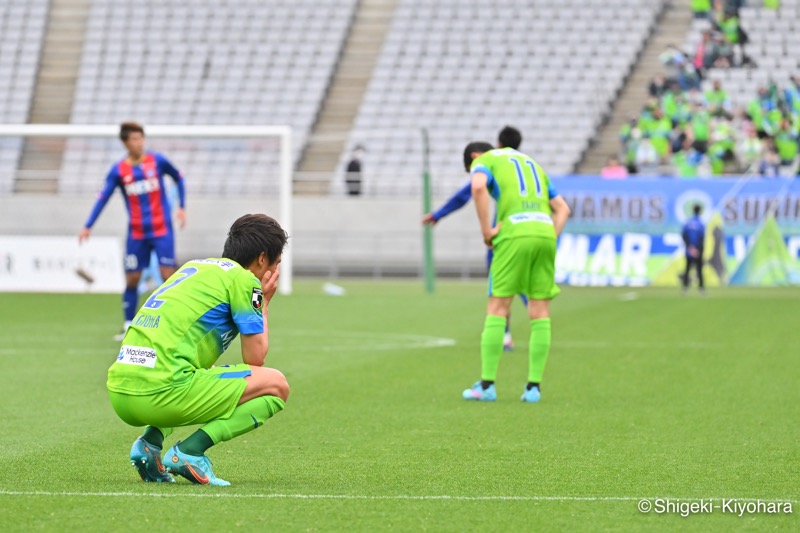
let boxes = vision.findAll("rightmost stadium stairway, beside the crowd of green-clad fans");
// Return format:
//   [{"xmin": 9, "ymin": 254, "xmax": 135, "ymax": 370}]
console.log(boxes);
[{"xmin": 577, "ymin": 0, "xmax": 692, "ymax": 174}]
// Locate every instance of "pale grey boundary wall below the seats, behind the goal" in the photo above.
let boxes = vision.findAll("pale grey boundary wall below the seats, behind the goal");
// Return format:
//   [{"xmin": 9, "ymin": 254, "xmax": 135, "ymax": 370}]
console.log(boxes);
[{"xmin": 0, "ymin": 195, "xmax": 486, "ymax": 282}]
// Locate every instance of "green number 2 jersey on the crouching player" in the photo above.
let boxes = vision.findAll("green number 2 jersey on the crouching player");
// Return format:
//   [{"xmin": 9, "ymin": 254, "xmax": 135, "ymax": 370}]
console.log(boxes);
[{"xmin": 108, "ymin": 259, "xmax": 264, "ymax": 395}]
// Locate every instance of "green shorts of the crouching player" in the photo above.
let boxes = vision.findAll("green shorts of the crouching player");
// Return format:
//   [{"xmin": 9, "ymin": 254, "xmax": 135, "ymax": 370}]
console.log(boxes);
[{"xmin": 108, "ymin": 364, "xmax": 252, "ymax": 428}]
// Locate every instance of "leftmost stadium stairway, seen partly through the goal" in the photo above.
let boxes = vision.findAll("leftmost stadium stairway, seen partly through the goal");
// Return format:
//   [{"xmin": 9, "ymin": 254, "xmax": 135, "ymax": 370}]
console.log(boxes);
[{"xmin": 14, "ymin": 0, "xmax": 91, "ymax": 193}]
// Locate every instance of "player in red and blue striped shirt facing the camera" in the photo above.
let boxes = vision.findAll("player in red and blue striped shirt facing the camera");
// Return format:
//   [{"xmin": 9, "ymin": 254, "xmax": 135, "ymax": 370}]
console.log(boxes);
[{"xmin": 78, "ymin": 122, "xmax": 186, "ymax": 340}]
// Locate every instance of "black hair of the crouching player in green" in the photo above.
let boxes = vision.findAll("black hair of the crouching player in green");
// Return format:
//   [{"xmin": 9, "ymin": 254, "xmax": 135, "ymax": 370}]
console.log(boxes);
[{"xmin": 222, "ymin": 214, "xmax": 289, "ymax": 268}]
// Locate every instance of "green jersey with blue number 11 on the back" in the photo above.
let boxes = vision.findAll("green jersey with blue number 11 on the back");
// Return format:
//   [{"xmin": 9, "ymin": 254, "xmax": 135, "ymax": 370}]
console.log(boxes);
[{"xmin": 470, "ymin": 148, "xmax": 558, "ymax": 243}]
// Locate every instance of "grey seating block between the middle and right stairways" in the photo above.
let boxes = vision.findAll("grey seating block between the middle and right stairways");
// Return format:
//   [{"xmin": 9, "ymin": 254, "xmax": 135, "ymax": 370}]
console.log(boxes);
[{"xmin": 333, "ymin": 0, "xmax": 663, "ymax": 195}]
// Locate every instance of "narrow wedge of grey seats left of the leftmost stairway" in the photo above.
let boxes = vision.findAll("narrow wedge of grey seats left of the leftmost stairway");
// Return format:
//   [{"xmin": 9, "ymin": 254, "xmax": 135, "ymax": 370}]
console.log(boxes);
[{"xmin": 0, "ymin": 0, "xmax": 50, "ymax": 193}]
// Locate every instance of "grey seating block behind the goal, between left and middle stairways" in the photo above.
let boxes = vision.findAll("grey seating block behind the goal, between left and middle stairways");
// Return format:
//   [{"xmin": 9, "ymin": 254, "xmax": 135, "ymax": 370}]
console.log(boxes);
[{"xmin": 59, "ymin": 0, "xmax": 356, "ymax": 194}]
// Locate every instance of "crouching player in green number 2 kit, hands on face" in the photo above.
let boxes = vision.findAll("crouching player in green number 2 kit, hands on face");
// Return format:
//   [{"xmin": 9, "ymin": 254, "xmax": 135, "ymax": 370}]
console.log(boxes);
[{"xmin": 107, "ymin": 215, "xmax": 289, "ymax": 485}]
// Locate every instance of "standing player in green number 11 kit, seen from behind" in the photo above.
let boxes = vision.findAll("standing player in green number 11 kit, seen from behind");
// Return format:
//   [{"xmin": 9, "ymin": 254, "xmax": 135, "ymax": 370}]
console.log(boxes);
[{"xmin": 463, "ymin": 142, "xmax": 570, "ymax": 402}]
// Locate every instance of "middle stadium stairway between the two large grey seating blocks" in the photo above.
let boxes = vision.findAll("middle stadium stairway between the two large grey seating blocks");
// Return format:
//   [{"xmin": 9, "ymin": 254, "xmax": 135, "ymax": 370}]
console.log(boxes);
[{"xmin": 295, "ymin": 0, "xmax": 396, "ymax": 194}]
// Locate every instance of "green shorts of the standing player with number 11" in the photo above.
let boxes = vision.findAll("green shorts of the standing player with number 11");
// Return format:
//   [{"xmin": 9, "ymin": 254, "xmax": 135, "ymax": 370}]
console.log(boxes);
[{"xmin": 489, "ymin": 237, "xmax": 561, "ymax": 300}]
